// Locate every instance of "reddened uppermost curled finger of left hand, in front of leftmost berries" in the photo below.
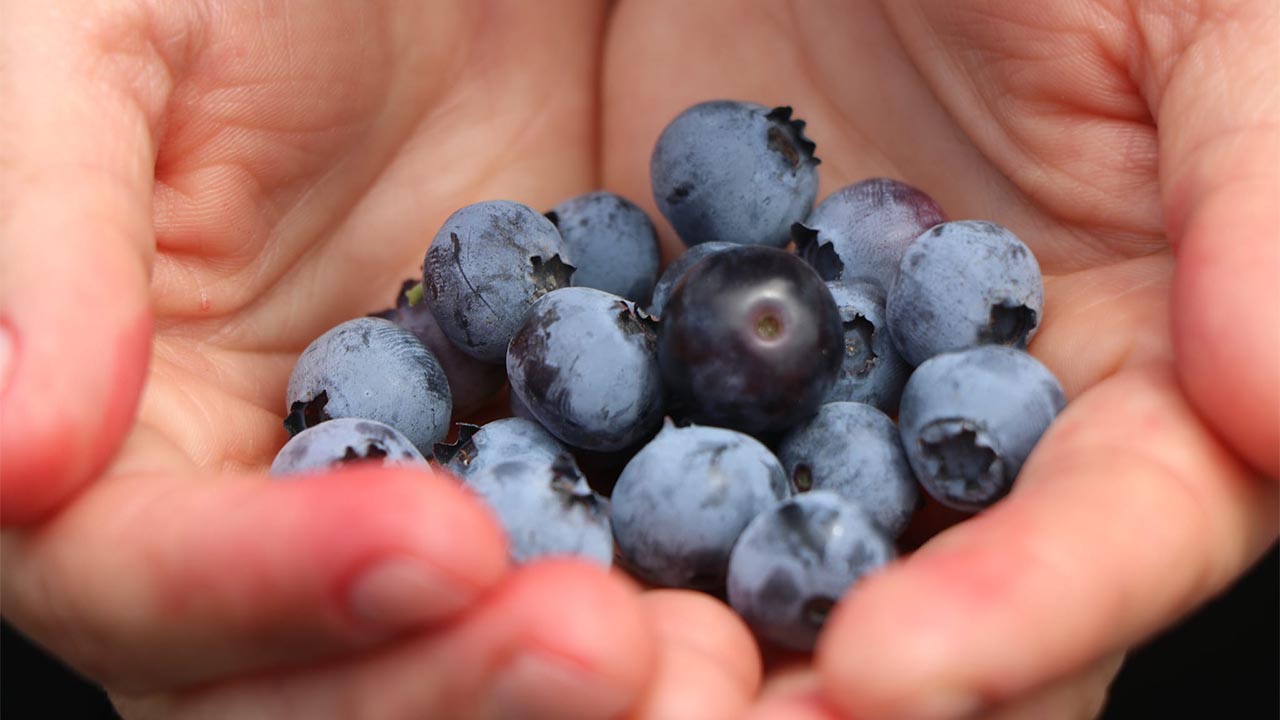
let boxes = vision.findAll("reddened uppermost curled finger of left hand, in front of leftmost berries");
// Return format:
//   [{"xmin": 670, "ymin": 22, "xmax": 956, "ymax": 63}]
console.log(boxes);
[{"xmin": 0, "ymin": 458, "xmax": 507, "ymax": 691}]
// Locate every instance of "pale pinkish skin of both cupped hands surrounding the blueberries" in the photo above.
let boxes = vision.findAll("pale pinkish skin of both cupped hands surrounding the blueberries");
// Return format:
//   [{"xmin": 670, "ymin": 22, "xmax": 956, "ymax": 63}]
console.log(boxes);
[{"xmin": 0, "ymin": 0, "xmax": 1280, "ymax": 720}]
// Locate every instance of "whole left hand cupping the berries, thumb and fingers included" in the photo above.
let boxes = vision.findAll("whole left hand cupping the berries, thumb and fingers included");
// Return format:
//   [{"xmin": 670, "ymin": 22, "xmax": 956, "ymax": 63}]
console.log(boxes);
[{"xmin": 0, "ymin": 1, "xmax": 759, "ymax": 719}]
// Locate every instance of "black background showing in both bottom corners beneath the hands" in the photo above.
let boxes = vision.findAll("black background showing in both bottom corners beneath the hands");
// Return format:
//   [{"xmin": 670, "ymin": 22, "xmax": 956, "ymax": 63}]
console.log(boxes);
[{"xmin": 0, "ymin": 547, "xmax": 1280, "ymax": 720}]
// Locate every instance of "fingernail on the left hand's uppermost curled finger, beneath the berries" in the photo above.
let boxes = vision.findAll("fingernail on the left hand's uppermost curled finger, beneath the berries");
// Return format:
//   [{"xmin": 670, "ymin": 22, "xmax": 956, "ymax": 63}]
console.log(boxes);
[{"xmin": 347, "ymin": 555, "xmax": 472, "ymax": 629}]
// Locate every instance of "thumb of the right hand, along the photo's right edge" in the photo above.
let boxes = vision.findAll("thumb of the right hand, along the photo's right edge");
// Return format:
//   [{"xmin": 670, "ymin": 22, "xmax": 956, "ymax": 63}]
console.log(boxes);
[{"xmin": 1149, "ymin": 3, "xmax": 1280, "ymax": 478}]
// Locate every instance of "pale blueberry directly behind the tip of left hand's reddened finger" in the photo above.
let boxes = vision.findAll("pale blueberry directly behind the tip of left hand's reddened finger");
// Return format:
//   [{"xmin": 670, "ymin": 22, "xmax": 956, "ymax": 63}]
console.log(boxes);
[{"xmin": 467, "ymin": 455, "xmax": 613, "ymax": 566}]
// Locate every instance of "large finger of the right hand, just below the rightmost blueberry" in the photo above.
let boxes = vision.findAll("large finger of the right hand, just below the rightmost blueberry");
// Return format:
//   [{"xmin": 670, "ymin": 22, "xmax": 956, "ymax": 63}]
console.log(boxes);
[{"xmin": 818, "ymin": 365, "xmax": 1277, "ymax": 719}]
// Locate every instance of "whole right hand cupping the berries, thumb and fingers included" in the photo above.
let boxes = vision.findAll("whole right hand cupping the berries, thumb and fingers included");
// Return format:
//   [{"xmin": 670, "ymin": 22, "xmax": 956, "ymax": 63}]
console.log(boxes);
[{"xmin": 603, "ymin": 0, "xmax": 1280, "ymax": 720}]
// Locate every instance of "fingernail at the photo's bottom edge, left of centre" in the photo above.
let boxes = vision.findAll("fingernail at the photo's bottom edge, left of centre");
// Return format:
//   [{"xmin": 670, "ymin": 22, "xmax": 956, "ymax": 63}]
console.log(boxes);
[{"xmin": 489, "ymin": 652, "xmax": 635, "ymax": 720}]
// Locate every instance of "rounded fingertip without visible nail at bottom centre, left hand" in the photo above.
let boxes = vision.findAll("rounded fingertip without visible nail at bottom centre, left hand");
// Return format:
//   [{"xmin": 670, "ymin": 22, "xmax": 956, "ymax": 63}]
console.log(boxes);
[{"xmin": 632, "ymin": 591, "xmax": 760, "ymax": 720}]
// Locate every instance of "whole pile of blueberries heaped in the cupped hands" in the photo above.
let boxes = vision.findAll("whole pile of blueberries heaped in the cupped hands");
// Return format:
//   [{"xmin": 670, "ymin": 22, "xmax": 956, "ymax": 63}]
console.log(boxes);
[{"xmin": 271, "ymin": 101, "xmax": 1065, "ymax": 650}]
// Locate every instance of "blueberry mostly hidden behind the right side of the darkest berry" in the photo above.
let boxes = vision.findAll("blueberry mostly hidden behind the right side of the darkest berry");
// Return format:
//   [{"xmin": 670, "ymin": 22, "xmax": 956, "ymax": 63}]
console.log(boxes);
[{"xmin": 824, "ymin": 282, "xmax": 911, "ymax": 414}]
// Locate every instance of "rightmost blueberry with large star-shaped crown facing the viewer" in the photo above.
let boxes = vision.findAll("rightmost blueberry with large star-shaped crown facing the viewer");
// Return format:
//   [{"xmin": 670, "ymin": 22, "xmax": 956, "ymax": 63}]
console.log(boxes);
[{"xmin": 899, "ymin": 345, "xmax": 1066, "ymax": 511}]
